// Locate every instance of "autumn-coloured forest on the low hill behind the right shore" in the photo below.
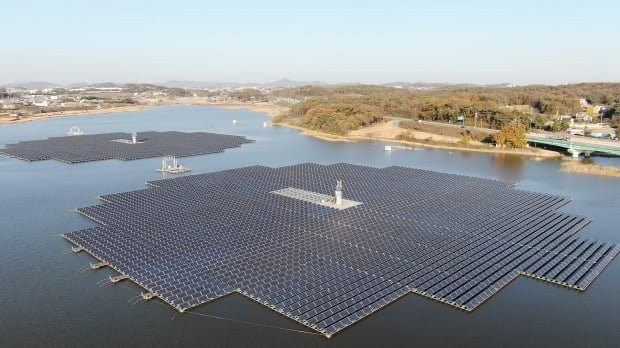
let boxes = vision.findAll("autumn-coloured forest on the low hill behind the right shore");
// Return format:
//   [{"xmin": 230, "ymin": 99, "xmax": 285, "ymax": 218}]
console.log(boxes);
[{"xmin": 271, "ymin": 83, "xmax": 620, "ymax": 134}]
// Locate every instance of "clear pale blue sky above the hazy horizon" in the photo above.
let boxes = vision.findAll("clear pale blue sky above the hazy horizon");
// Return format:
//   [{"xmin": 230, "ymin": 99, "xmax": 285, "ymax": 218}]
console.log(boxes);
[{"xmin": 0, "ymin": 0, "xmax": 620, "ymax": 84}]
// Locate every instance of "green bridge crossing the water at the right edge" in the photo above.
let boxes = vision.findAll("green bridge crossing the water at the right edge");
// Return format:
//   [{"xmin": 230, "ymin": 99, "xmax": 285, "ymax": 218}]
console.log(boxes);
[{"xmin": 525, "ymin": 133, "xmax": 620, "ymax": 157}]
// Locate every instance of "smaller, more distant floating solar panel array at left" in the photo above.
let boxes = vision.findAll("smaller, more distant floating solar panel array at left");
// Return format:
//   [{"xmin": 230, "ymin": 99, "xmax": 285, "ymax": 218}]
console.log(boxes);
[{"xmin": 0, "ymin": 132, "xmax": 253, "ymax": 163}]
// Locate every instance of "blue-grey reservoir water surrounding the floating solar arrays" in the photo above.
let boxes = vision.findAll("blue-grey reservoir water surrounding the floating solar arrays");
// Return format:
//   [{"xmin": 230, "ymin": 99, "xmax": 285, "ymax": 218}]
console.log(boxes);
[{"xmin": 0, "ymin": 106, "xmax": 620, "ymax": 347}]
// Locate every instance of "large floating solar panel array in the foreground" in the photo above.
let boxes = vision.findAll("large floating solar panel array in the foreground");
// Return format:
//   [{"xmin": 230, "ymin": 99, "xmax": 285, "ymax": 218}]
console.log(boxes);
[{"xmin": 64, "ymin": 164, "xmax": 619, "ymax": 337}]
